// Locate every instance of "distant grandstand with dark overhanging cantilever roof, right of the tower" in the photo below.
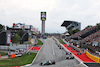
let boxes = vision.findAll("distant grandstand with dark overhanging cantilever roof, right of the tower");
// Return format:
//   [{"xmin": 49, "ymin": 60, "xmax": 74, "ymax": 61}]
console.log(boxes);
[{"xmin": 61, "ymin": 21, "xmax": 81, "ymax": 38}]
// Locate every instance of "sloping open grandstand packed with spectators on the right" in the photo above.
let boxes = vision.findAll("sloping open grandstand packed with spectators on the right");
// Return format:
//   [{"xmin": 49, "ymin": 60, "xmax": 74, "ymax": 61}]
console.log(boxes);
[{"xmin": 66, "ymin": 25, "xmax": 100, "ymax": 57}]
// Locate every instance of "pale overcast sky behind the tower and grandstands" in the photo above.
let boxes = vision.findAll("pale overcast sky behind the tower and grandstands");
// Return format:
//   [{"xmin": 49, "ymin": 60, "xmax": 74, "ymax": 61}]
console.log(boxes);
[{"xmin": 0, "ymin": 0, "xmax": 100, "ymax": 33}]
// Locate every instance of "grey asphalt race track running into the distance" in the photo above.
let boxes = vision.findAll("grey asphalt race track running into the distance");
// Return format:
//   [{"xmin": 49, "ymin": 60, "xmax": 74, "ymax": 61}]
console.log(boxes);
[{"xmin": 30, "ymin": 38, "xmax": 79, "ymax": 67}]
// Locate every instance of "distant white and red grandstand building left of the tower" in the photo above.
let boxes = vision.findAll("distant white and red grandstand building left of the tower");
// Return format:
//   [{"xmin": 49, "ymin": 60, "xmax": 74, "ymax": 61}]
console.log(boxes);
[{"xmin": 7, "ymin": 23, "xmax": 40, "ymax": 35}]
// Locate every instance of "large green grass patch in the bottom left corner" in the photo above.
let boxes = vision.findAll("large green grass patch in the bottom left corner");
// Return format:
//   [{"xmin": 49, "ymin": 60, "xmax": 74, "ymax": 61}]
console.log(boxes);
[{"xmin": 0, "ymin": 53, "xmax": 36, "ymax": 67}]
